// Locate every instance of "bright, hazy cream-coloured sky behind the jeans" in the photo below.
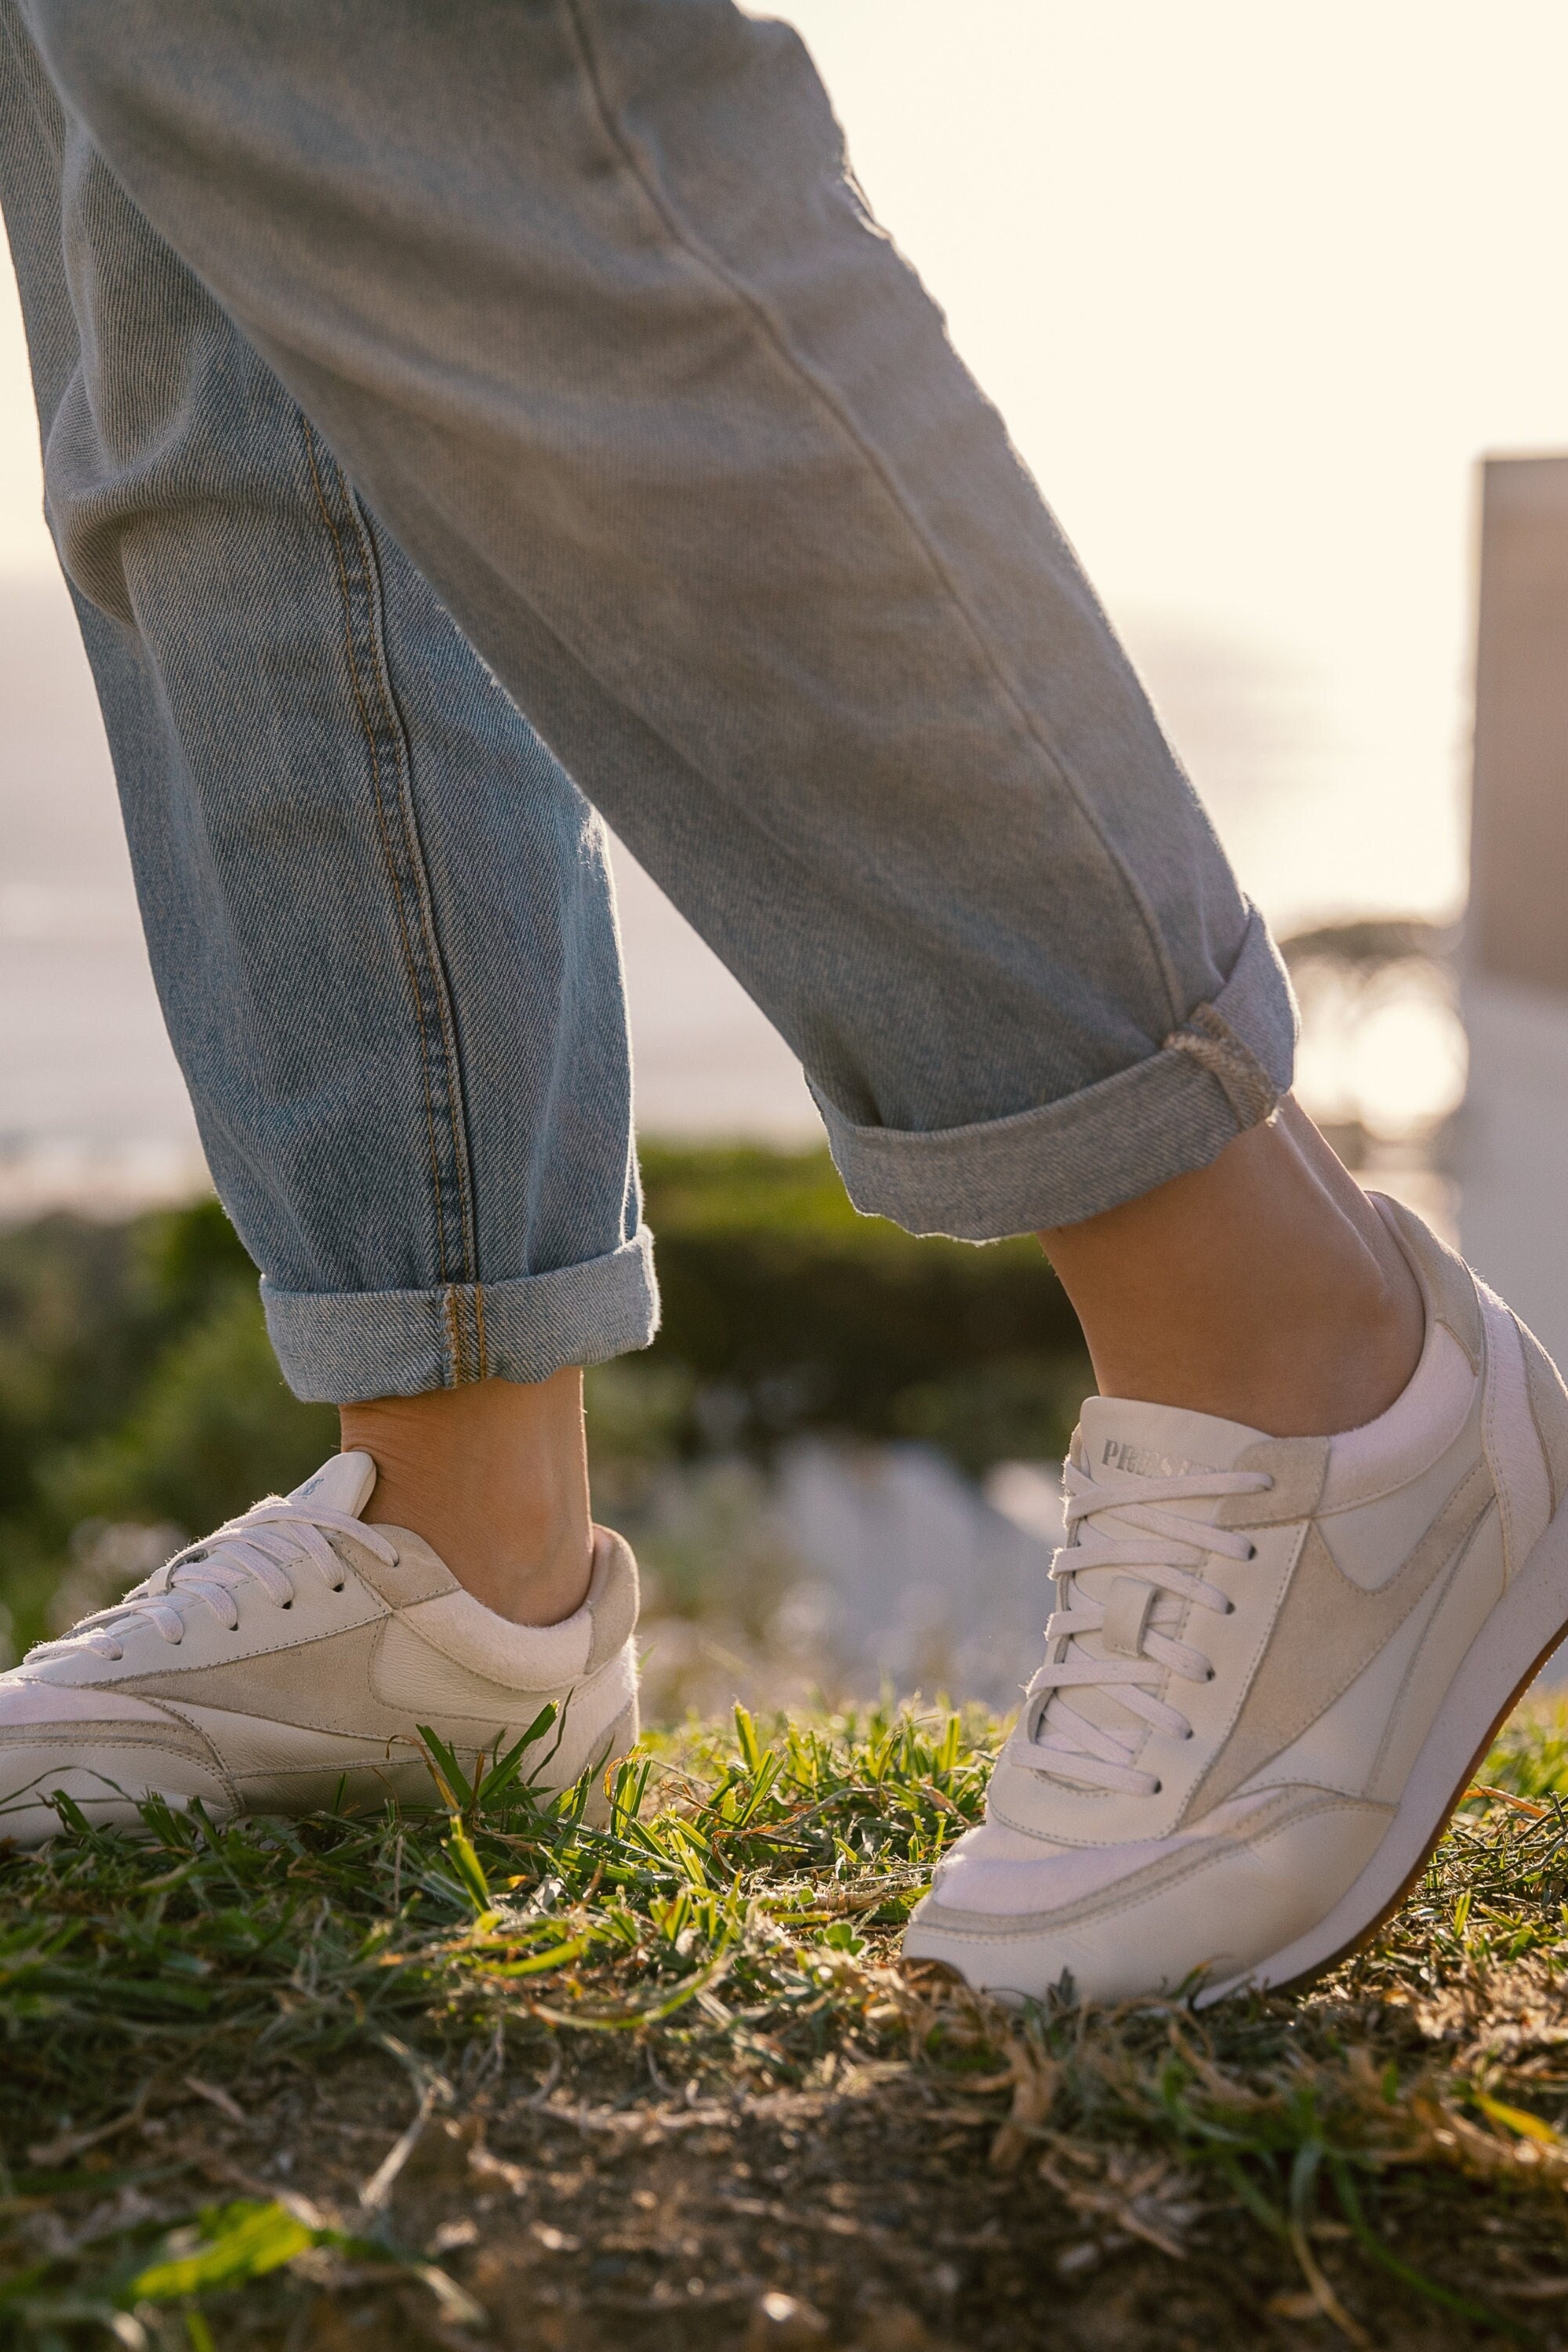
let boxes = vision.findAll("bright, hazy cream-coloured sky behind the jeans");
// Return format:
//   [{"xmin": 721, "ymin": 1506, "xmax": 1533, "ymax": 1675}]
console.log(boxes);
[{"xmin": 0, "ymin": 0, "xmax": 1568, "ymax": 922}]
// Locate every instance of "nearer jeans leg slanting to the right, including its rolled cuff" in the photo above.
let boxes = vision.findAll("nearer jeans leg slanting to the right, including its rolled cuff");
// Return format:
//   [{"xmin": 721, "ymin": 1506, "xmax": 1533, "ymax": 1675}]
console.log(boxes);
[{"xmin": 28, "ymin": 0, "xmax": 1293, "ymax": 1270}]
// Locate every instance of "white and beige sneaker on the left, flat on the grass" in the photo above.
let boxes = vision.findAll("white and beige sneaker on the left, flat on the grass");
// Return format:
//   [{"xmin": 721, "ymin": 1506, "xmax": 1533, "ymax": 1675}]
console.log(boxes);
[{"xmin": 0, "ymin": 1454, "xmax": 637, "ymax": 1846}]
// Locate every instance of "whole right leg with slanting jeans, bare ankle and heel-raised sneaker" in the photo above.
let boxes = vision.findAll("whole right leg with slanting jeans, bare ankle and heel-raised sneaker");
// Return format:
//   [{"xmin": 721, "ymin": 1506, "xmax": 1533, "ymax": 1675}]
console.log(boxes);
[{"xmin": 12, "ymin": 0, "xmax": 1568, "ymax": 1994}]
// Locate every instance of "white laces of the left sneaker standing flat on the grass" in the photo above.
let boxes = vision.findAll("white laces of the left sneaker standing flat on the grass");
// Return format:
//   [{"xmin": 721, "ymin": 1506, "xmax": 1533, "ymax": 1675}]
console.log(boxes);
[{"xmin": 28, "ymin": 1498, "xmax": 397, "ymax": 1663}]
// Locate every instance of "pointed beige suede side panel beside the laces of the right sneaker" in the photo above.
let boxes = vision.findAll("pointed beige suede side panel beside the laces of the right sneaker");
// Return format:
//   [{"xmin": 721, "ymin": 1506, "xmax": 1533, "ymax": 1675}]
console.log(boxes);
[{"xmin": 1182, "ymin": 1463, "xmax": 1493, "ymax": 1820}]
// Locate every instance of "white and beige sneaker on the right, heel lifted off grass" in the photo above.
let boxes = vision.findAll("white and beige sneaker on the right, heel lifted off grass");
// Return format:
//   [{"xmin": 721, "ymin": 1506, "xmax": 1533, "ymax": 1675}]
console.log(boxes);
[{"xmin": 905, "ymin": 1202, "xmax": 1568, "ymax": 2002}]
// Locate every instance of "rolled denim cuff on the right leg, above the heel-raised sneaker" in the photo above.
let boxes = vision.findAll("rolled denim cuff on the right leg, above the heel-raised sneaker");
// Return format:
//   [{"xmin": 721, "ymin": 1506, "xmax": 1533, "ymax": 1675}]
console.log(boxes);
[{"xmin": 811, "ymin": 910, "xmax": 1295, "ymax": 1242}]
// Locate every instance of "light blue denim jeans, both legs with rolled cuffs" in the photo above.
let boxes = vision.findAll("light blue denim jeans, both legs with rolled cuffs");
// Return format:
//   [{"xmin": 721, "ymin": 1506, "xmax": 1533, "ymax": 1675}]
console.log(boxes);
[{"xmin": 0, "ymin": 0, "xmax": 1293, "ymax": 1399}]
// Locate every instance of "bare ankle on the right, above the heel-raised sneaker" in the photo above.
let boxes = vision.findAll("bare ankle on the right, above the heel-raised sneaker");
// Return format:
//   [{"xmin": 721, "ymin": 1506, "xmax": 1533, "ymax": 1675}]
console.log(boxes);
[{"xmin": 1041, "ymin": 1103, "xmax": 1425, "ymax": 1437}]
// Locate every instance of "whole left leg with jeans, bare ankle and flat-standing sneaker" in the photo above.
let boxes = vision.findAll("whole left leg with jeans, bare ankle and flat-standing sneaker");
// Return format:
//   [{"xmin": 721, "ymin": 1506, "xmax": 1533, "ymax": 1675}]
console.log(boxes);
[{"xmin": 0, "ymin": 0, "xmax": 656, "ymax": 1842}]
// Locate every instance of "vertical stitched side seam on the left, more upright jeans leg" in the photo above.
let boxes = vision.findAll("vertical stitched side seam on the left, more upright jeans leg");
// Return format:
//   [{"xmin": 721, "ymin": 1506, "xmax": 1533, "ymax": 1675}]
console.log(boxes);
[{"xmin": 301, "ymin": 433, "xmax": 485, "ymax": 1385}]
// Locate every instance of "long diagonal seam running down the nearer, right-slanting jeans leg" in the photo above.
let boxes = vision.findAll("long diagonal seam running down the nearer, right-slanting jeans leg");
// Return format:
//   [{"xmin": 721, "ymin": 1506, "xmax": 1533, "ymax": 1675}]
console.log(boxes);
[{"xmin": 562, "ymin": 0, "xmax": 1189, "ymax": 1023}]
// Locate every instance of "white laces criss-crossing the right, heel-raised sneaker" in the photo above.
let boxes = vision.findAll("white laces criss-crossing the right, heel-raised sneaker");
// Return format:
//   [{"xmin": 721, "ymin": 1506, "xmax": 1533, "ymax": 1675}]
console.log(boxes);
[{"xmin": 1020, "ymin": 1463, "xmax": 1274, "ymax": 1797}]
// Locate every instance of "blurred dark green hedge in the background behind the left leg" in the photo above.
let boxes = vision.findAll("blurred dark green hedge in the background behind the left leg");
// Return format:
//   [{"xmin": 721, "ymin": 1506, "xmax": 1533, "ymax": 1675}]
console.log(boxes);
[{"xmin": 0, "ymin": 1145, "xmax": 1088, "ymax": 1618}]
